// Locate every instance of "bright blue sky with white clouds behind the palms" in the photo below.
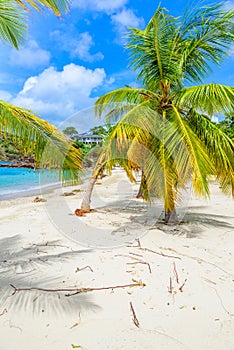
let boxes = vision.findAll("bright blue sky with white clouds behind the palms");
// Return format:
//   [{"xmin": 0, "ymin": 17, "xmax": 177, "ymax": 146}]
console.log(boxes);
[{"xmin": 0, "ymin": 0, "xmax": 234, "ymax": 131}]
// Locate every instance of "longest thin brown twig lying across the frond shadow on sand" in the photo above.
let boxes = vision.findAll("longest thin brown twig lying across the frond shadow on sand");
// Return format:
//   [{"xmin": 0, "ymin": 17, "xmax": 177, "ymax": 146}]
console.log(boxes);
[{"xmin": 10, "ymin": 281, "xmax": 145, "ymax": 297}]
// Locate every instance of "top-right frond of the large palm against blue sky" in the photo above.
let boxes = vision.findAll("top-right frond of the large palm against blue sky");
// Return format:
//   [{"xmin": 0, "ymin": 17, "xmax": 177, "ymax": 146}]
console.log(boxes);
[{"xmin": 180, "ymin": 3, "xmax": 234, "ymax": 82}]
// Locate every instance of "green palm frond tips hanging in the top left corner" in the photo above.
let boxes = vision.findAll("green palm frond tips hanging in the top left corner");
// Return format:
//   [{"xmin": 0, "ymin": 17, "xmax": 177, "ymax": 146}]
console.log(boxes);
[{"xmin": 0, "ymin": 0, "xmax": 70, "ymax": 49}]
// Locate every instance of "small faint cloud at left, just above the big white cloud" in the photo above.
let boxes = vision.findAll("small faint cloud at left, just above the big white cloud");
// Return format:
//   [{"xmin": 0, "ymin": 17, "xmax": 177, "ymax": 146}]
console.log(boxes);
[{"xmin": 10, "ymin": 40, "xmax": 50, "ymax": 68}]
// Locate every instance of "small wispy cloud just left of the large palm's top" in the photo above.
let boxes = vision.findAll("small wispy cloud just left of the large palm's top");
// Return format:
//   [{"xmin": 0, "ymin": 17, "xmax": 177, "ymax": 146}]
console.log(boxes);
[{"xmin": 111, "ymin": 8, "xmax": 145, "ymax": 41}]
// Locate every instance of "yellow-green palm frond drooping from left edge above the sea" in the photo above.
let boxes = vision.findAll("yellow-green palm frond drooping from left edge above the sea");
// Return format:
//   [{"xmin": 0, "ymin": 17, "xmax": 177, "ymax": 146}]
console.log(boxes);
[{"xmin": 0, "ymin": 101, "xmax": 81, "ymax": 181}]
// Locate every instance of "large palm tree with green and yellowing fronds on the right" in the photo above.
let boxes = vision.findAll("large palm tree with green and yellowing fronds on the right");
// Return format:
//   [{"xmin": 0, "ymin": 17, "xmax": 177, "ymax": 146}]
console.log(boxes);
[{"xmin": 79, "ymin": 4, "xmax": 234, "ymax": 222}]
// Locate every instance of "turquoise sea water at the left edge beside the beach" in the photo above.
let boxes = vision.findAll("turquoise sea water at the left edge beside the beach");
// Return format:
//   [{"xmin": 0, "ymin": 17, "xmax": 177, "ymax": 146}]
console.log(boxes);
[{"xmin": 0, "ymin": 162, "xmax": 58, "ymax": 200}]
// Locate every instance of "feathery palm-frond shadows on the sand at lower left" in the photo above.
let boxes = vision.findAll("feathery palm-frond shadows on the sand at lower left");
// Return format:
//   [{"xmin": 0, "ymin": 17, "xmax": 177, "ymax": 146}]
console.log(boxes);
[{"xmin": 0, "ymin": 235, "xmax": 100, "ymax": 317}]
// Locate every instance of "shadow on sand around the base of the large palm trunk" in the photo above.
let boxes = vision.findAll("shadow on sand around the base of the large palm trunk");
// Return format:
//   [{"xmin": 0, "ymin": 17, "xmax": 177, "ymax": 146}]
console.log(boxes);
[{"xmin": 94, "ymin": 199, "xmax": 234, "ymax": 238}]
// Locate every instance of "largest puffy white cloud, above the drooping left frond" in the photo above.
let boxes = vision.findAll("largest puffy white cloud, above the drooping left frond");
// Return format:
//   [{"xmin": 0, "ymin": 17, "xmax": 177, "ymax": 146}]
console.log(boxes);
[{"xmin": 10, "ymin": 63, "xmax": 106, "ymax": 124}]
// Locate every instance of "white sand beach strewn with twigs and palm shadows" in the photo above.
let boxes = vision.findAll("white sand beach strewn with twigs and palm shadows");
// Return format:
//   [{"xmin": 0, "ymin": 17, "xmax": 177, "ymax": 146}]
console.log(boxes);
[{"xmin": 0, "ymin": 170, "xmax": 234, "ymax": 350}]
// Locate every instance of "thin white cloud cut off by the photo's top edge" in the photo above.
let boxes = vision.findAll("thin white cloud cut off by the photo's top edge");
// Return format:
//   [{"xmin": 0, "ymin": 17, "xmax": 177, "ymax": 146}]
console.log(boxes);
[{"xmin": 72, "ymin": 0, "xmax": 129, "ymax": 14}]
